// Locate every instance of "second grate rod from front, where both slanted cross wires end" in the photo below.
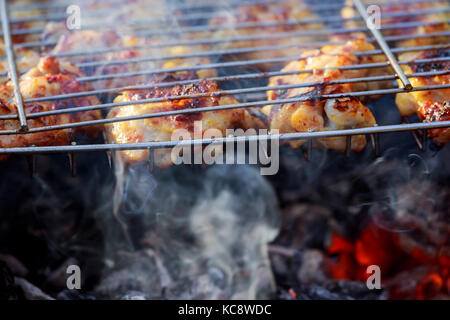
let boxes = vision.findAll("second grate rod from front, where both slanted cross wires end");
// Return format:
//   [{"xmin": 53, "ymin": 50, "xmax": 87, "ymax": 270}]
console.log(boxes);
[{"xmin": 0, "ymin": 84, "xmax": 450, "ymax": 135}]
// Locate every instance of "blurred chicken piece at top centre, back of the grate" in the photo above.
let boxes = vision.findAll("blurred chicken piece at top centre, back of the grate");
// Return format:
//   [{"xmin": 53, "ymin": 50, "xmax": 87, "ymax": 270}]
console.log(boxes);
[{"xmin": 209, "ymin": 1, "xmax": 325, "ymax": 70}]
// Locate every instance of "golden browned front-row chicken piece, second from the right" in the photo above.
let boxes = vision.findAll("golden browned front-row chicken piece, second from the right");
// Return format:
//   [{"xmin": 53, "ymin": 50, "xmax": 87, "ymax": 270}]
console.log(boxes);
[{"xmin": 263, "ymin": 40, "xmax": 382, "ymax": 152}]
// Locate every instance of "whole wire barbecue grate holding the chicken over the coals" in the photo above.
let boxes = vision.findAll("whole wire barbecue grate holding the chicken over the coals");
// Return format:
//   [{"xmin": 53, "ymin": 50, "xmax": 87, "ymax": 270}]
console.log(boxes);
[{"xmin": 0, "ymin": 0, "xmax": 450, "ymax": 170}]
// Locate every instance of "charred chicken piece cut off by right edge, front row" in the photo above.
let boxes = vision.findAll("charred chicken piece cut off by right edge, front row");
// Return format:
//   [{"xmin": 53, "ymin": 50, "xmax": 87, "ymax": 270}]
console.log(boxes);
[{"xmin": 396, "ymin": 48, "xmax": 450, "ymax": 145}]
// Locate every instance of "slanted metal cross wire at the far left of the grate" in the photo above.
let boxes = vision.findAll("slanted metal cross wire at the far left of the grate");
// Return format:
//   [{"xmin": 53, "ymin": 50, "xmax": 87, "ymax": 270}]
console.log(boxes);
[{"xmin": 0, "ymin": 0, "xmax": 28, "ymax": 131}]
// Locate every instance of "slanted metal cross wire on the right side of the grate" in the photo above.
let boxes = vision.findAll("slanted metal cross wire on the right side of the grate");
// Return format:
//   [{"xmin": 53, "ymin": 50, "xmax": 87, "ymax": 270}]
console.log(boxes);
[{"xmin": 353, "ymin": 0, "xmax": 413, "ymax": 91}]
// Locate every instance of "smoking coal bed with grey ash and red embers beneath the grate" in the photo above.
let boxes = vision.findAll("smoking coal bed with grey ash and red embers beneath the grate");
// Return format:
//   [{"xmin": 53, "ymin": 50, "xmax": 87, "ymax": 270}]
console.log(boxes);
[{"xmin": 0, "ymin": 1, "xmax": 450, "ymax": 300}]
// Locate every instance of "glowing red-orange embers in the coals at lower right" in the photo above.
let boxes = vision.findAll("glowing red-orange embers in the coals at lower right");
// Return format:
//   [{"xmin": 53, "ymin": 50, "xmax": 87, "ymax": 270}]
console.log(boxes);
[{"xmin": 326, "ymin": 221, "xmax": 450, "ymax": 300}]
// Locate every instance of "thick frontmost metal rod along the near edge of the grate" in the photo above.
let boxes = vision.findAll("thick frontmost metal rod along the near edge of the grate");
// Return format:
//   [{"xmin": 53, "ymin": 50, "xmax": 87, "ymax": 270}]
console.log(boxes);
[{"xmin": 0, "ymin": 121, "xmax": 450, "ymax": 155}]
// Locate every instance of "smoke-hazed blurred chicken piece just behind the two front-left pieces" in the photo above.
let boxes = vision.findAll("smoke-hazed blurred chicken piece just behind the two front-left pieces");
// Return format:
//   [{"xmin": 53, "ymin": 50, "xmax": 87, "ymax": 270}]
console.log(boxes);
[{"xmin": 45, "ymin": 30, "xmax": 217, "ymax": 89}]
